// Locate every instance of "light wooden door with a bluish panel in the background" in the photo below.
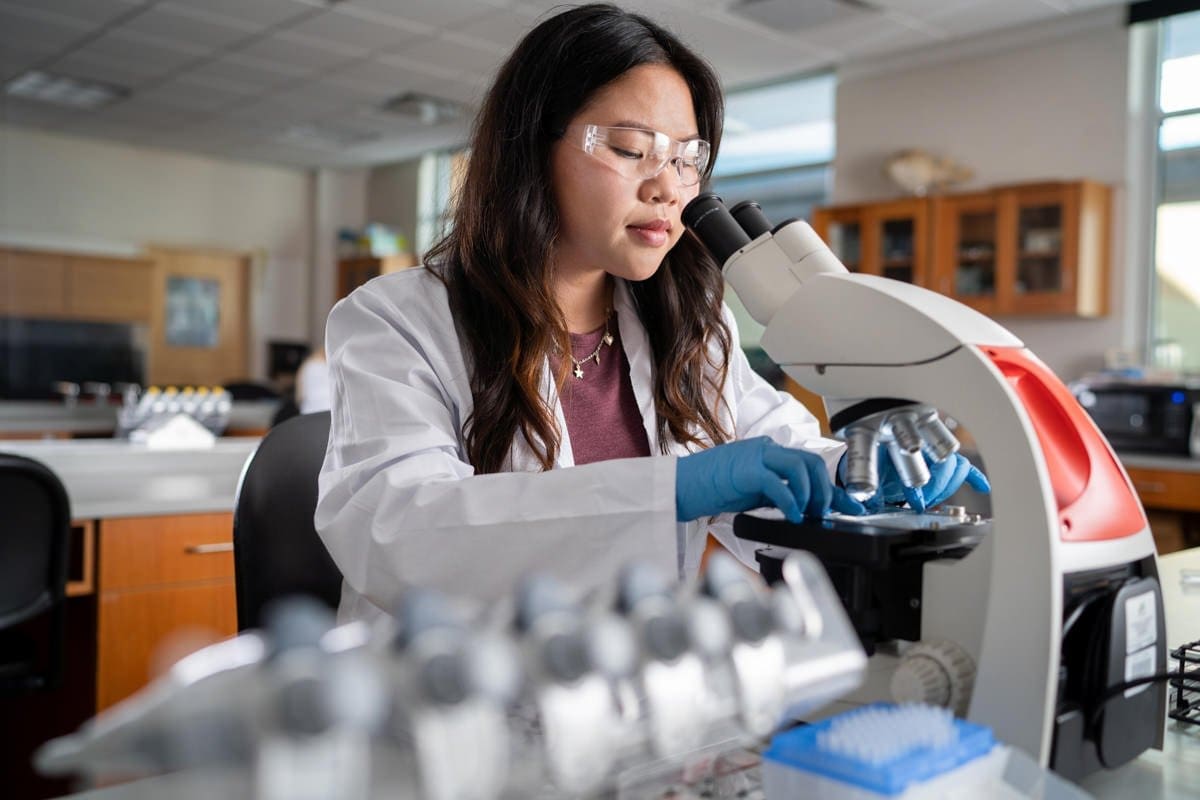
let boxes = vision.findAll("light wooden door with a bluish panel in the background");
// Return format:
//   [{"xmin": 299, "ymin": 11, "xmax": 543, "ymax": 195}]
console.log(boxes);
[{"xmin": 146, "ymin": 248, "xmax": 250, "ymax": 385}]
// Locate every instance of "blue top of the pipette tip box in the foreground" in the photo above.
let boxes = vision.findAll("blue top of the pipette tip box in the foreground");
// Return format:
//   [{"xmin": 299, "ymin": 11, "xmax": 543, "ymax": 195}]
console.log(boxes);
[{"xmin": 763, "ymin": 703, "xmax": 996, "ymax": 795}]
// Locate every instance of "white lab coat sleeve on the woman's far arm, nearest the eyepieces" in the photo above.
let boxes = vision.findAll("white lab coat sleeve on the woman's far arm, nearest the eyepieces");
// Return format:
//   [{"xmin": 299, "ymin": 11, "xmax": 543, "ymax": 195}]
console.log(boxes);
[{"xmin": 708, "ymin": 307, "xmax": 846, "ymax": 569}]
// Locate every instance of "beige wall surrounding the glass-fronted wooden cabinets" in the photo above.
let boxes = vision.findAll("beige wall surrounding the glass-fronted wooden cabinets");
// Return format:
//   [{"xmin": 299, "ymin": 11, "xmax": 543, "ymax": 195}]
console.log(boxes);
[{"xmin": 833, "ymin": 10, "xmax": 1132, "ymax": 379}]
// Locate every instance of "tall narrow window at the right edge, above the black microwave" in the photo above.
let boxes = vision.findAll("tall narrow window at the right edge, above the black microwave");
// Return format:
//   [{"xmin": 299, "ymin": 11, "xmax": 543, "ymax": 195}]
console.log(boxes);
[{"xmin": 1150, "ymin": 12, "xmax": 1200, "ymax": 372}]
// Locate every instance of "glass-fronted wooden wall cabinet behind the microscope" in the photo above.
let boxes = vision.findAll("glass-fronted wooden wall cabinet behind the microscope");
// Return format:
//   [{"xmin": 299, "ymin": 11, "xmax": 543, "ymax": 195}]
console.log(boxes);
[{"xmin": 812, "ymin": 181, "xmax": 1111, "ymax": 317}]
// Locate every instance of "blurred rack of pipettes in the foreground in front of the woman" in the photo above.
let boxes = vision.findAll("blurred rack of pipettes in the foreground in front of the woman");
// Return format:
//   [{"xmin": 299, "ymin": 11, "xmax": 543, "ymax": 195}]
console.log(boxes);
[{"xmin": 36, "ymin": 553, "xmax": 866, "ymax": 800}]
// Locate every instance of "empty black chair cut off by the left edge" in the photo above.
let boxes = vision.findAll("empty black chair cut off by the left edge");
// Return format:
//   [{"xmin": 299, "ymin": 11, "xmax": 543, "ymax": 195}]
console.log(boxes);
[{"xmin": 0, "ymin": 453, "xmax": 71, "ymax": 692}]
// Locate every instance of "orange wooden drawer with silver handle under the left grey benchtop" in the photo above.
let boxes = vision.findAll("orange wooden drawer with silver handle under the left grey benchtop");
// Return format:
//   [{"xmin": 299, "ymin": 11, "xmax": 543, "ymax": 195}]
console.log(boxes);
[{"xmin": 100, "ymin": 512, "xmax": 233, "ymax": 591}]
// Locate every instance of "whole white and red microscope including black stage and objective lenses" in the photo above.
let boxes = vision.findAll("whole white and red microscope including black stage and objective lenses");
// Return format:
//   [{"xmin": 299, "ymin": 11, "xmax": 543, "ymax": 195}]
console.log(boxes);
[{"xmin": 683, "ymin": 194, "xmax": 1166, "ymax": 778}]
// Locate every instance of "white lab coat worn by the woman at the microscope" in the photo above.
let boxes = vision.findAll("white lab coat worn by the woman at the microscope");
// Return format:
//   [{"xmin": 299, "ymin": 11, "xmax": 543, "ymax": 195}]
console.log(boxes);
[{"xmin": 316, "ymin": 269, "xmax": 844, "ymax": 622}]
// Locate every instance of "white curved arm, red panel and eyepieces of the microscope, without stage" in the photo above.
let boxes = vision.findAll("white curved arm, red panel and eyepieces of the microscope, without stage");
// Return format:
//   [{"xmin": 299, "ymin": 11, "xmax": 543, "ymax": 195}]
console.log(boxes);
[{"xmin": 684, "ymin": 196, "xmax": 1166, "ymax": 772}]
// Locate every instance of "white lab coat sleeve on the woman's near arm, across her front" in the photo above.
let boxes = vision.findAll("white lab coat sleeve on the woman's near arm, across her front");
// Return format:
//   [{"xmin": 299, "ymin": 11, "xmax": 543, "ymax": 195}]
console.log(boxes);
[{"xmin": 314, "ymin": 285, "xmax": 678, "ymax": 609}]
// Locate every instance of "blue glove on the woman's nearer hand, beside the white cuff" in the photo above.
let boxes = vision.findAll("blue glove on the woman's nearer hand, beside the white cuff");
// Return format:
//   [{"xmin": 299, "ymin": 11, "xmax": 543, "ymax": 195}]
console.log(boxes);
[{"xmin": 676, "ymin": 437, "xmax": 865, "ymax": 522}]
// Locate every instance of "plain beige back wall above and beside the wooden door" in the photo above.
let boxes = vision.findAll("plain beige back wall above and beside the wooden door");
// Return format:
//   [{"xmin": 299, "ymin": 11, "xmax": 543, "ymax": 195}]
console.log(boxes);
[{"xmin": 0, "ymin": 126, "xmax": 314, "ymax": 377}]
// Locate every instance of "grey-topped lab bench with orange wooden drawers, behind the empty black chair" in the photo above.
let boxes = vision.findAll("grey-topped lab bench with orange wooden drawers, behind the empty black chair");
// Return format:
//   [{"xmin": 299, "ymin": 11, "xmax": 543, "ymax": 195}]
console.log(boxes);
[{"xmin": 0, "ymin": 438, "xmax": 259, "ymax": 712}]
